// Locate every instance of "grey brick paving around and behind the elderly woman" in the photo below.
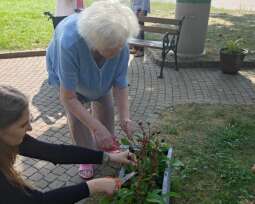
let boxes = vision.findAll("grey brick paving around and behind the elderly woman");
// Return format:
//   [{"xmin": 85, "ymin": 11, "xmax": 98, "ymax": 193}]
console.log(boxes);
[{"xmin": 0, "ymin": 56, "xmax": 255, "ymax": 203}]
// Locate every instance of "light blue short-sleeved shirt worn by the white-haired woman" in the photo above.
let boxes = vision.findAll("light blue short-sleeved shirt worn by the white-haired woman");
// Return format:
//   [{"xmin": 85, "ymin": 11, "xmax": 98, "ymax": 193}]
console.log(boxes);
[{"xmin": 46, "ymin": 14, "xmax": 129, "ymax": 101}]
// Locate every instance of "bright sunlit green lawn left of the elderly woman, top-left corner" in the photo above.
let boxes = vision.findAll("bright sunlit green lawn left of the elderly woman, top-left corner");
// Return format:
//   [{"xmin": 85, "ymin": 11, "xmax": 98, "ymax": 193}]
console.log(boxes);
[{"xmin": 0, "ymin": 0, "xmax": 54, "ymax": 51}]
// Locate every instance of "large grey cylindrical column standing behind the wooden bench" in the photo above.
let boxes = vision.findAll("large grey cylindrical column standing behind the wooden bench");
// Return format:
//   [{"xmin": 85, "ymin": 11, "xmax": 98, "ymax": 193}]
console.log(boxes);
[{"xmin": 175, "ymin": 0, "xmax": 211, "ymax": 57}]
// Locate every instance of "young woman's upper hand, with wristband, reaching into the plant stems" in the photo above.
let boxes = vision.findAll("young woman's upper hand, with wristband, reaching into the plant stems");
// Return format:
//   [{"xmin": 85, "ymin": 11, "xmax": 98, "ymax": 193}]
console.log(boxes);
[{"xmin": 105, "ymin": 151, "xmax": 137, "ymax": 165}]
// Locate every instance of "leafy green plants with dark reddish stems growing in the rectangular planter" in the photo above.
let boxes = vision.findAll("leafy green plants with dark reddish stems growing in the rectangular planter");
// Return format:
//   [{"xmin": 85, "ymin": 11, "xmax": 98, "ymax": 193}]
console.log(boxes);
[{"xmin": 100, "ymin": 123, "xmax": 174, "ymax": 204}]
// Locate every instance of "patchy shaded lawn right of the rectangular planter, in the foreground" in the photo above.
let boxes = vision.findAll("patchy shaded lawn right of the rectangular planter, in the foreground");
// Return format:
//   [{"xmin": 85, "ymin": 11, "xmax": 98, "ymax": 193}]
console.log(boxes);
[{"xmin": 162, "ymin": 104, "xmax": 255, "ymax": 204}]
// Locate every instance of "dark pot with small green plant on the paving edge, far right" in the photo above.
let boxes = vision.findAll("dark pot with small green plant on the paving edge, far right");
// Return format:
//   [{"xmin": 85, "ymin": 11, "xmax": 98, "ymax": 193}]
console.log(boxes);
[{"xmin": 220, "ymin": 38, "xmax": 248, "ymax": 74}]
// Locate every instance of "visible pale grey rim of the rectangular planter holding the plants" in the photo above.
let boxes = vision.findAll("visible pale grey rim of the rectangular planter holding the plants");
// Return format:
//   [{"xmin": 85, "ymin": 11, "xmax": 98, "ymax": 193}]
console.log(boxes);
[{"xmin": 119, "ymin": 148, "xmax": 173, "ymax": 204}]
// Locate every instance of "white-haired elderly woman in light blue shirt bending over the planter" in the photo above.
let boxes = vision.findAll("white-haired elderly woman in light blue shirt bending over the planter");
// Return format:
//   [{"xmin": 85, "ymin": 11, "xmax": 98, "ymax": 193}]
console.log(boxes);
[{"xmin": 46, "ymin": 1, "xmax": 139, "ymax": 178}]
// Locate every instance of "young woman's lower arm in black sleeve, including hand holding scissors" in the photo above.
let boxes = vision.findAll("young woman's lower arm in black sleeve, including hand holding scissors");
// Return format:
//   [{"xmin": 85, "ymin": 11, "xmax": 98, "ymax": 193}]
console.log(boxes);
[{"xmin": 0, "ymin": 171, "xmax": 118, "ymax": 204}]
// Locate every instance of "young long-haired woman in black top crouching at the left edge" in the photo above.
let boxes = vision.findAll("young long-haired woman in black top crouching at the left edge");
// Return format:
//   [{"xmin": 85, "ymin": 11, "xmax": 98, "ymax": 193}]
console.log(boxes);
[{"xmin": 0, "ymin": 86, "xmax": 134, "ymax": 204}]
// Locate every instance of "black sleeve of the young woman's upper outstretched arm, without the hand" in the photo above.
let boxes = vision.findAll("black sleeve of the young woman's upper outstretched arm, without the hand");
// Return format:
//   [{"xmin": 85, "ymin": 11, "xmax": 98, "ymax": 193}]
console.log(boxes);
[{"xmin": 19, "ymin": 135, "xmax": 103, "ymax": 164}]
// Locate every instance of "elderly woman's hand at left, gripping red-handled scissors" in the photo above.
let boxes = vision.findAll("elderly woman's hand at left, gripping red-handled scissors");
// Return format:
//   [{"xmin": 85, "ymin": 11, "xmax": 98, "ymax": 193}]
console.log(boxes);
[{"xmin": 92, "ymin": 122, "xmax": 113, "ymax": 149}]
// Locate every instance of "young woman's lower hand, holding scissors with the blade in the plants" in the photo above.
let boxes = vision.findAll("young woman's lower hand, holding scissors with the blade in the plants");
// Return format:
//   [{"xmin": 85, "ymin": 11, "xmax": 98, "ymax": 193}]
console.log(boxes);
[{"xmin": 87, "ymin": 178, "xmax": 121, "ymax": 195}]
